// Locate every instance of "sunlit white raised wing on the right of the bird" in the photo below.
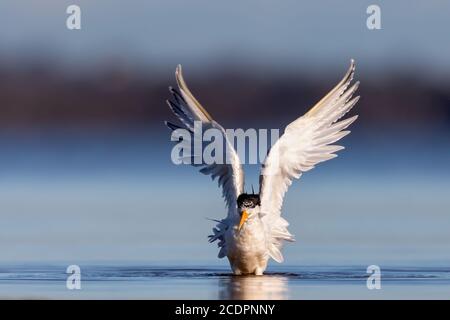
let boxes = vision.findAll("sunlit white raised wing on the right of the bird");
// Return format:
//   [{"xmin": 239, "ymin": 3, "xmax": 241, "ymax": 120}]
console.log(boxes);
[{"xmin": 260, "ymin": 60, "xmax": 359, "ymax": 261}]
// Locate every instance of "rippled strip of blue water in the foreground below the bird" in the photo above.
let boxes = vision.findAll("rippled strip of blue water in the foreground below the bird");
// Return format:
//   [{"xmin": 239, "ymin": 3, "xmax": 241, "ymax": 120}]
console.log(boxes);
[{"xmin": 0, "ymin": 265, "xmax": 450, "ymax": 299}]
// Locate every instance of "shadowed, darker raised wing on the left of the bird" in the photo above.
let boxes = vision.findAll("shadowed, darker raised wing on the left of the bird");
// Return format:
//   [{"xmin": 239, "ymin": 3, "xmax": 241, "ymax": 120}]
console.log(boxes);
[{"xmin": 166, "ymin": 65, "xmax": 244, "ymax": 217}]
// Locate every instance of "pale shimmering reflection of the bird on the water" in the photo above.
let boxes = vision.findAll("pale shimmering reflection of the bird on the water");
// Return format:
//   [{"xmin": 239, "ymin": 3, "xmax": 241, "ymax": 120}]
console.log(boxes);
[{"xmin": 219, "ymin": 275, "xmax": 288, "ymax": 300}]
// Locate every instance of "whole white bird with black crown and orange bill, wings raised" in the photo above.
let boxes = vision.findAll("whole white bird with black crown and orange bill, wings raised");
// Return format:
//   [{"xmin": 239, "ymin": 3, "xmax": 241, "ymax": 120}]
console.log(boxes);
[{"xmin": 166, "ymin": 60, "xmax": 359, "ymax": 275}]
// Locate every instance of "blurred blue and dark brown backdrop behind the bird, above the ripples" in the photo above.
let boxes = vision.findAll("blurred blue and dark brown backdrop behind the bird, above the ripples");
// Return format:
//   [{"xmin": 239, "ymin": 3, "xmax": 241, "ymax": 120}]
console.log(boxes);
[{"xmin": 0, "ymin": 0, "xmax": 450, "ymax": 266}]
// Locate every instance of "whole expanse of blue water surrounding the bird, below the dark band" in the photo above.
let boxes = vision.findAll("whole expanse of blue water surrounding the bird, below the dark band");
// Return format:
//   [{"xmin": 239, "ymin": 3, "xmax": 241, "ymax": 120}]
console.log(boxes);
[{"xmin": 0, "ymin": 132, "xmax": 450, "ymax": 299}]
